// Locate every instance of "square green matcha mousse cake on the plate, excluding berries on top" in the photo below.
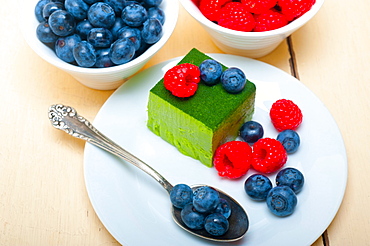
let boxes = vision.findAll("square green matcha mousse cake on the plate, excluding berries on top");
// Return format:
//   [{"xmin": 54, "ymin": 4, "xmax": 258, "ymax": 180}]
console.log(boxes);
[{"xmin": 147, "ymin": 49, "xmax": 256, "ymax": 167}]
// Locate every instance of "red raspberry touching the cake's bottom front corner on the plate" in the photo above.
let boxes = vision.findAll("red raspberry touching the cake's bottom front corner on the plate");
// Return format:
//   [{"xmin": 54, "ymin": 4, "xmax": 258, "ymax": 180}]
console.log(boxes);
[{"xmin": 213, "ymin": 141, "xmax": 252, "ymax": 179}]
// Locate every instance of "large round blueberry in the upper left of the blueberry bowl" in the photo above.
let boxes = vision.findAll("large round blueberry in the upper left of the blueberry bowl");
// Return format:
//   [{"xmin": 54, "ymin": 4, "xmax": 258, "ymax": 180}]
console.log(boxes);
[{"xmin": 49, "ymin": 10, "xmax": 76, "ymax": 37}]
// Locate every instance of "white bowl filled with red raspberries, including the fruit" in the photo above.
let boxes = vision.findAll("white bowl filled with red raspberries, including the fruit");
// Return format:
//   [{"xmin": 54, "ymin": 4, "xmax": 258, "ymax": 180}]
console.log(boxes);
[{"xmin": 180, "ymin": 0, "xmax": 324, "ymax": 58}]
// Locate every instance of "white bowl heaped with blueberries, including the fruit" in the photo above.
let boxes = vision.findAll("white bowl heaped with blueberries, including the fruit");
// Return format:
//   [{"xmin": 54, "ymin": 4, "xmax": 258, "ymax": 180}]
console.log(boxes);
[{"xmin": 21, "ymin": 0, "xmax": 178, "ymax": 90}]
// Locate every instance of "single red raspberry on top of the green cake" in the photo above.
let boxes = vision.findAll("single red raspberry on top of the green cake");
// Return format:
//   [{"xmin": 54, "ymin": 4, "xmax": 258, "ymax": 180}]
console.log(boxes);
[{"xmin": 163, "ymin": 63, "xmax": 200, "ymax": 97}]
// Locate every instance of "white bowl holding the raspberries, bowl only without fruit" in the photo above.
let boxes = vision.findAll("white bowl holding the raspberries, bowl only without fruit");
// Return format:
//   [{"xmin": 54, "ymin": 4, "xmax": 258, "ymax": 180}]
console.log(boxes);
[{"xmin": 180, "ymin": 0, "xmax": 324, "ymax": 58}]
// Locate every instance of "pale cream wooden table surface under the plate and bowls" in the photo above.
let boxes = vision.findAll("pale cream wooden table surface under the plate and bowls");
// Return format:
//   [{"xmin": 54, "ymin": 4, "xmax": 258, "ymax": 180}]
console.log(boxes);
[{"xmin": 0, "ymin": 0, "xmax": 370, "ymax": 246}]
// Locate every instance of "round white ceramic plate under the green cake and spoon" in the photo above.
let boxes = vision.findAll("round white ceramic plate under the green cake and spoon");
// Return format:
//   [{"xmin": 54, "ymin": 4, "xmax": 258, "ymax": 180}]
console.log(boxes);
[{"xmin": 81, "ymin": 54, "xmax": 347, "ymax": 246}]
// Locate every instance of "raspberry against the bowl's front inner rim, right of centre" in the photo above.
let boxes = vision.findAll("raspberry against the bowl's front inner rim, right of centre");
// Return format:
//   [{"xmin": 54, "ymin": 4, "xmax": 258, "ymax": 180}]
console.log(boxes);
[{"xmin": 254, "ymin": 10, "xmax": 288, "ymax": 32}]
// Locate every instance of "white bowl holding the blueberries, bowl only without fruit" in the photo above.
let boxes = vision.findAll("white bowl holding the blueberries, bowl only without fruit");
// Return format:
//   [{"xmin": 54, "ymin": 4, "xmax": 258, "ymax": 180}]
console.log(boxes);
[{"xmin": 20, "ymin": 0, "xmax": 179, "ymax": 90}]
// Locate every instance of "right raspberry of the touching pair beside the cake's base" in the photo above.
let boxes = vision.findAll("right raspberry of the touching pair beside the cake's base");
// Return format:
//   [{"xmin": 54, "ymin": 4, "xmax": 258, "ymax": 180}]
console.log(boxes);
[{"xmin": 252, "ymin": 138, "xmax": 288, "ymax": 173}]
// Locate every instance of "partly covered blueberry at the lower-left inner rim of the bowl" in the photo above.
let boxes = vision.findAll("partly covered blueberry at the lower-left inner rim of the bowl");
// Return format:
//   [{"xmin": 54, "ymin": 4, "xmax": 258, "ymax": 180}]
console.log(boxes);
[{"xmin": 55, "ymin": 34, "xmax": 81, "ymax": 63}]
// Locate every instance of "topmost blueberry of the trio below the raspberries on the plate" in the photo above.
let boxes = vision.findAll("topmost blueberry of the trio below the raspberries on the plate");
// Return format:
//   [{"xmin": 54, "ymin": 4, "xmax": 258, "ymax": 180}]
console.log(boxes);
[{"xmin": 276, "ymin": 167, "xmax": 304, "ymax": 194}]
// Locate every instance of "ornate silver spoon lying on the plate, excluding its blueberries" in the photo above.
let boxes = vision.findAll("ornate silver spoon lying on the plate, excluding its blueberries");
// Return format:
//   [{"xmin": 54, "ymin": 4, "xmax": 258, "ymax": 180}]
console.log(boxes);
[{"xmin": 49, "ymin": 104, "xmax": 249, "ymax": 242}]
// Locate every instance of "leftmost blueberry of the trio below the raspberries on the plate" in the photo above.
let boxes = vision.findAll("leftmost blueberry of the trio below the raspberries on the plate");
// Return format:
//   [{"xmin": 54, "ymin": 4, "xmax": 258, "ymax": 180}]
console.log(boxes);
[{"xmin": 244, "ymin": 174, "xmax": 272, "ymax": 201}]
